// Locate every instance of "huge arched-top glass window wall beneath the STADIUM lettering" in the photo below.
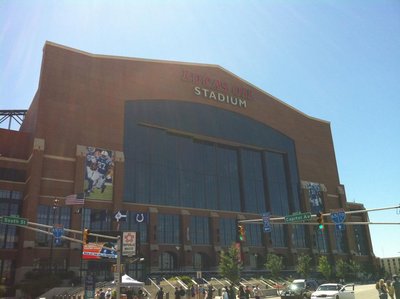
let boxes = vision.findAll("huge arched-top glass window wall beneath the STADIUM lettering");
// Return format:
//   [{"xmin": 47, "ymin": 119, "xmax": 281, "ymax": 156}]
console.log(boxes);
[{"xmin": 124, "ymin": 101, "xmax": 300, "ymax": 224}]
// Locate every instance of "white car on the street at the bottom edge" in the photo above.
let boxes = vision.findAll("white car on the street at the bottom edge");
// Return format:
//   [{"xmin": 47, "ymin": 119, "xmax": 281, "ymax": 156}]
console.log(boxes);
[{"xmin": 311, "ymin": 283, "xmax": 355, "ymax": 299}]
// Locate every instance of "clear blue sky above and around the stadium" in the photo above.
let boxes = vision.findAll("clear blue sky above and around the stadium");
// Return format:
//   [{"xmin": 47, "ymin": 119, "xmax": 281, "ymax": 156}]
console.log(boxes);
[{"xmin": 0, "ymin": 0, "xmax": 400, "ymax": 257}]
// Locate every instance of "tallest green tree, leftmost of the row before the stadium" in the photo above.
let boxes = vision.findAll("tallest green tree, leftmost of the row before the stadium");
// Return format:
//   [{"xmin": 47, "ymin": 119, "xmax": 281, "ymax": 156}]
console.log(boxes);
[{"xmin": 219, "ymin": 245, "xmax": 242, "ymax": 284}]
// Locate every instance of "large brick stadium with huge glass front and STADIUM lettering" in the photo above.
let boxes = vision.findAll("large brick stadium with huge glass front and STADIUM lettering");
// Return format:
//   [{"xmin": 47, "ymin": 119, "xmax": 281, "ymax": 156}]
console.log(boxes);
[{"xmin": 0, "ymin": 42, "xmax": 375, "ymax": 296}]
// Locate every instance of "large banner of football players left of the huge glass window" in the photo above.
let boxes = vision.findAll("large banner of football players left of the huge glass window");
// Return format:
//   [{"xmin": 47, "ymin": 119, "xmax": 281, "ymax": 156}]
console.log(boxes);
[{"xmin": 85, "ymin": 146, "xmax": 115, "ymax": 200}]
